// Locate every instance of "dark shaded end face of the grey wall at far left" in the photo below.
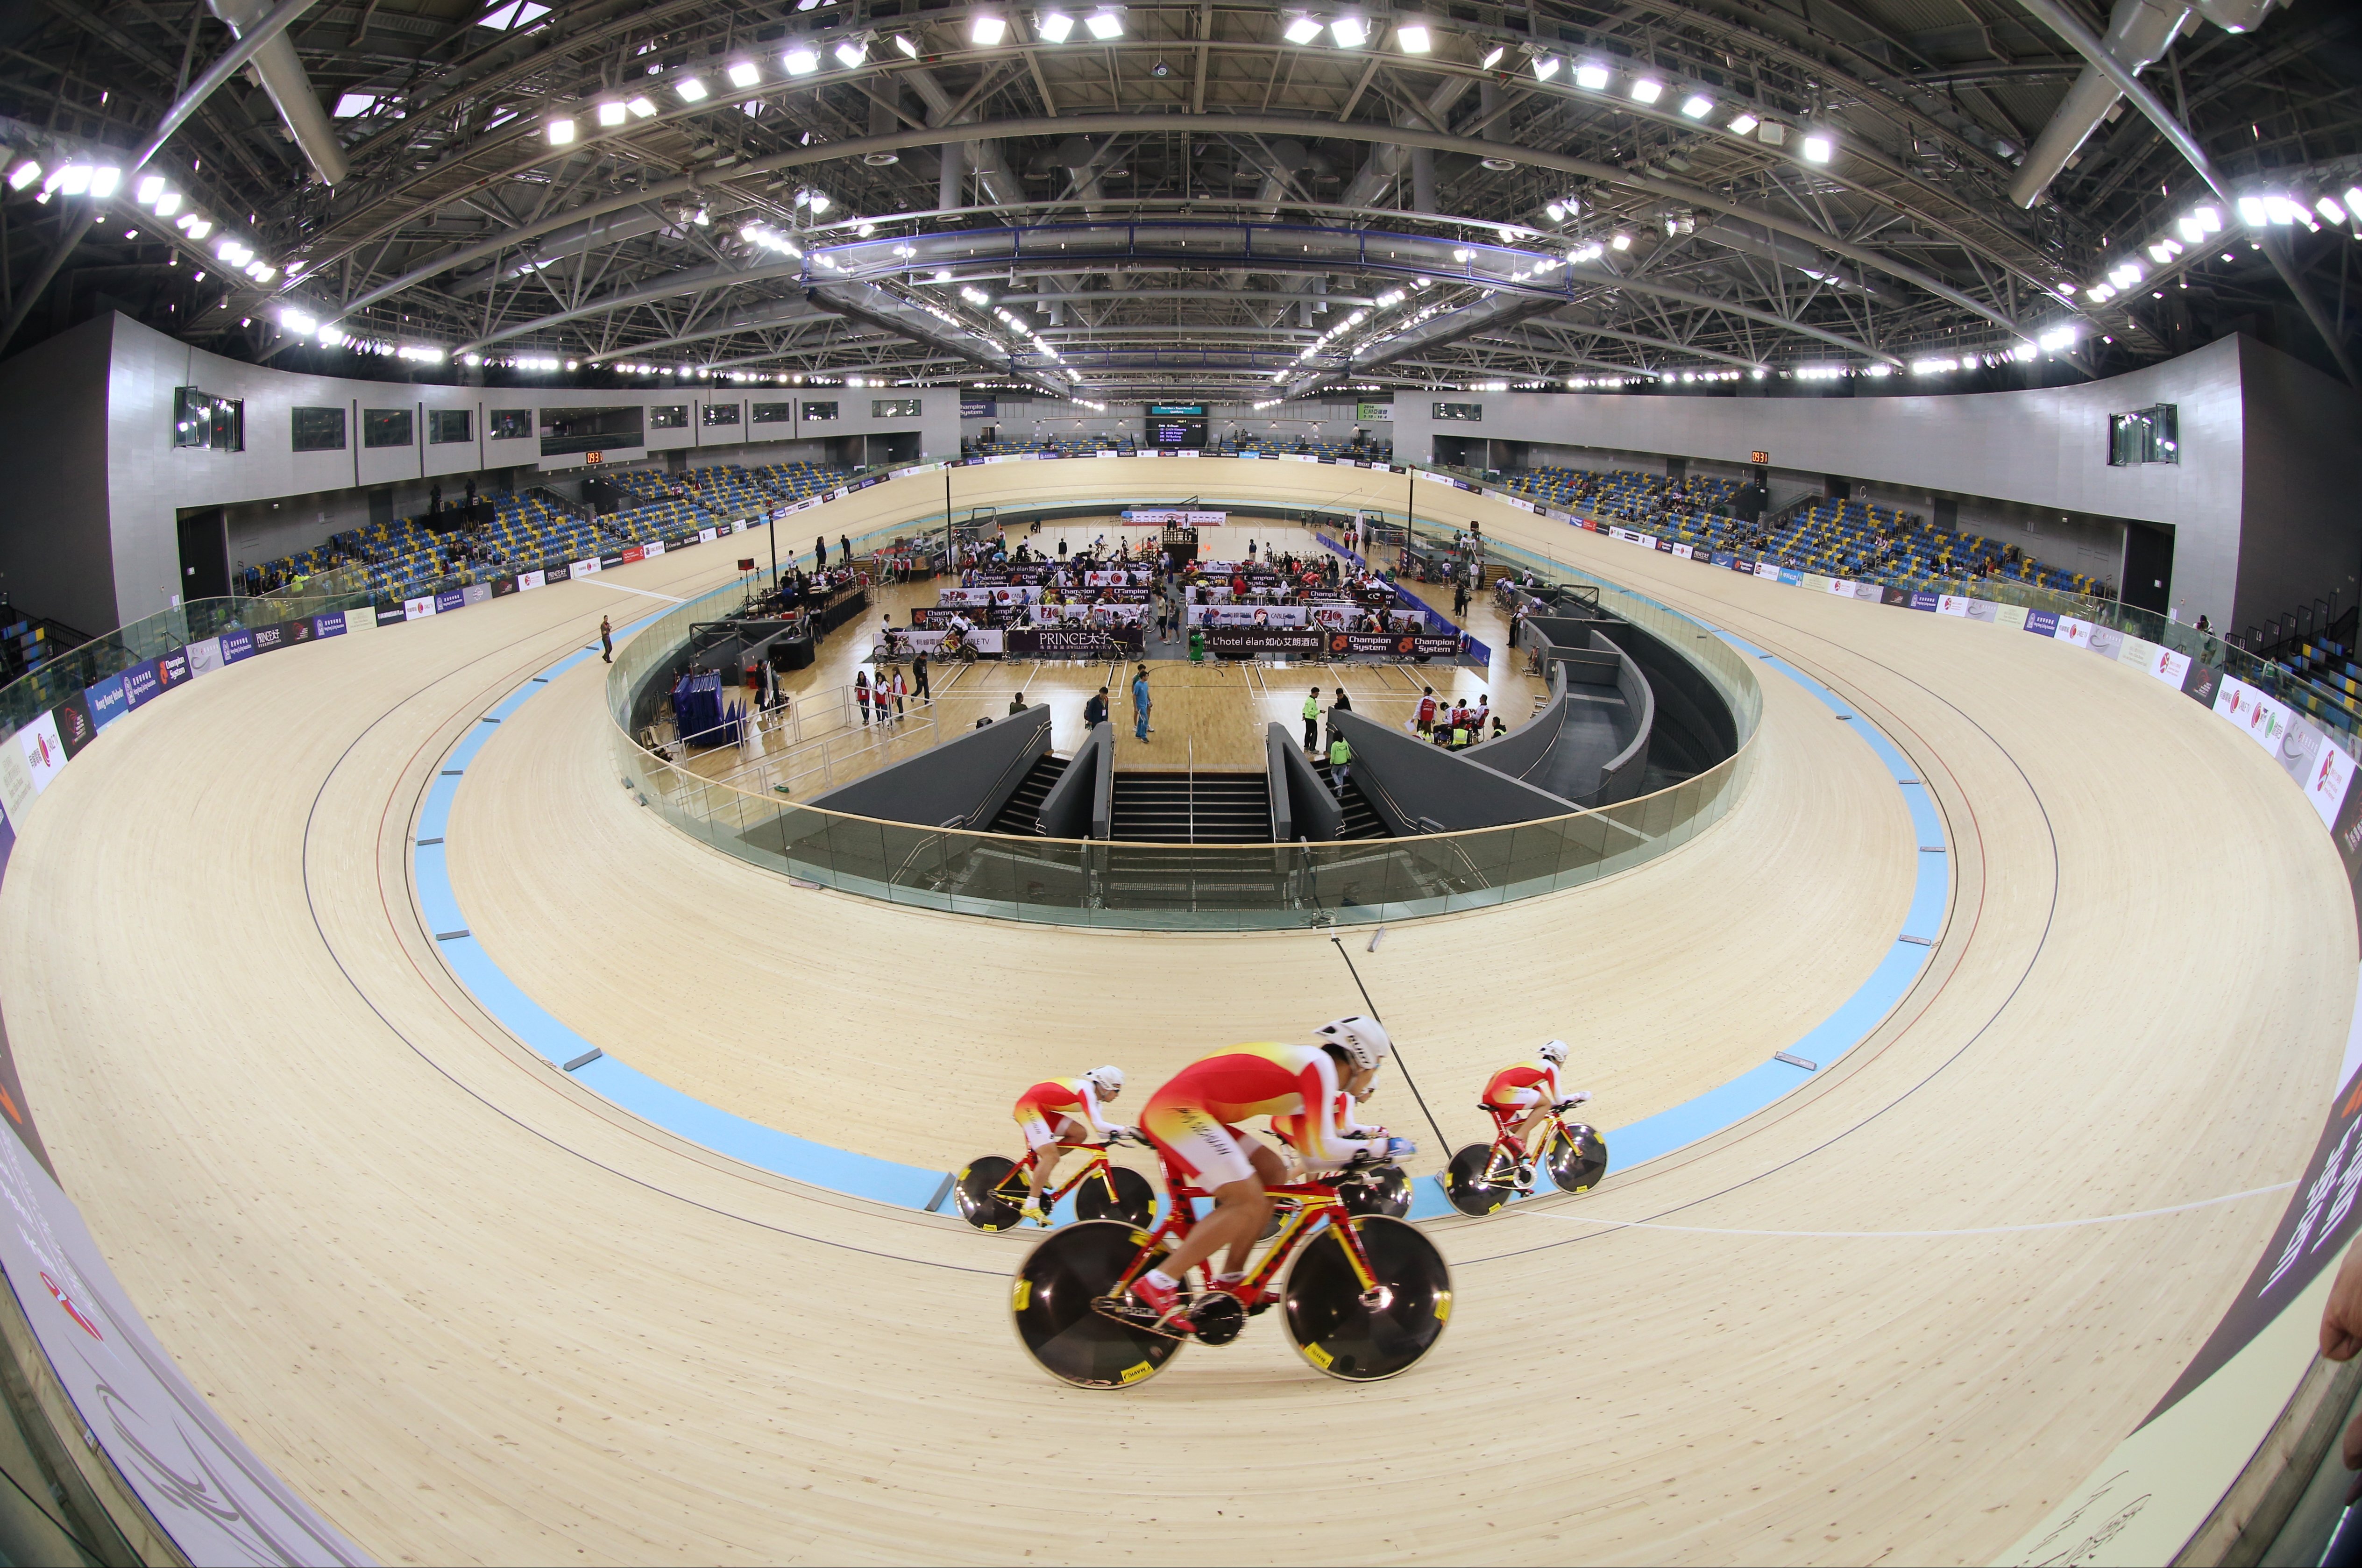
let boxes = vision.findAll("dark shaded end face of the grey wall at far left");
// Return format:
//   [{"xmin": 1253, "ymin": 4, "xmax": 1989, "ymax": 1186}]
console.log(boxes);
[{"xmin": 0, "ymin": 316, "xmax": 116, "ymax": 635}]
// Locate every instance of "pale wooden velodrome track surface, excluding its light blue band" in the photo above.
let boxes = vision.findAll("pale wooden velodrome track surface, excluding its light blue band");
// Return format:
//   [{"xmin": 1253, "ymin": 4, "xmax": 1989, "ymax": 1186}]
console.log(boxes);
[{"xmin": 0, "ymin": 463, "xmax": 2355, "ymax": 1563}]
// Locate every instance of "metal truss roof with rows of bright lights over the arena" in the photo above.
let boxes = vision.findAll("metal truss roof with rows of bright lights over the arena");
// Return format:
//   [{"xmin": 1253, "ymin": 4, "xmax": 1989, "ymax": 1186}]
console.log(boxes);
[{"xmin": 0, "ymin": 0, "xmax": 2362, "ymax": 399}]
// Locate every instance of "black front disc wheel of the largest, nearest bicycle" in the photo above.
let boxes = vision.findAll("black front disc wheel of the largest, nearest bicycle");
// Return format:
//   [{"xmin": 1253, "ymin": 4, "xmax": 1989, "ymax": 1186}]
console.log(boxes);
[{"xmin": 1283, "ymin": 1214, "xmax": 1453, "ymax": 1384}]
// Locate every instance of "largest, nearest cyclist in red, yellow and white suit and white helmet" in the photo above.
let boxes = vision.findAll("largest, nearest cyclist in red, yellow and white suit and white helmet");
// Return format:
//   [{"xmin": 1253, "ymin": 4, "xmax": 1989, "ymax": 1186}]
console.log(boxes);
[{"xmin": 1131, "ymin": 1015, "xmax": 1417, "ymax": 1329}]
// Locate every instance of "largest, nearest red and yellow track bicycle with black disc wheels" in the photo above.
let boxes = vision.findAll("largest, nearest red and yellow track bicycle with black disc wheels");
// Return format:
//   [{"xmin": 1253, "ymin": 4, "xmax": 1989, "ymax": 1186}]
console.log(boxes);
[{"xmin": 1008, "ymin": 1164, "xmax": 1453, "ymax": 1389}]
